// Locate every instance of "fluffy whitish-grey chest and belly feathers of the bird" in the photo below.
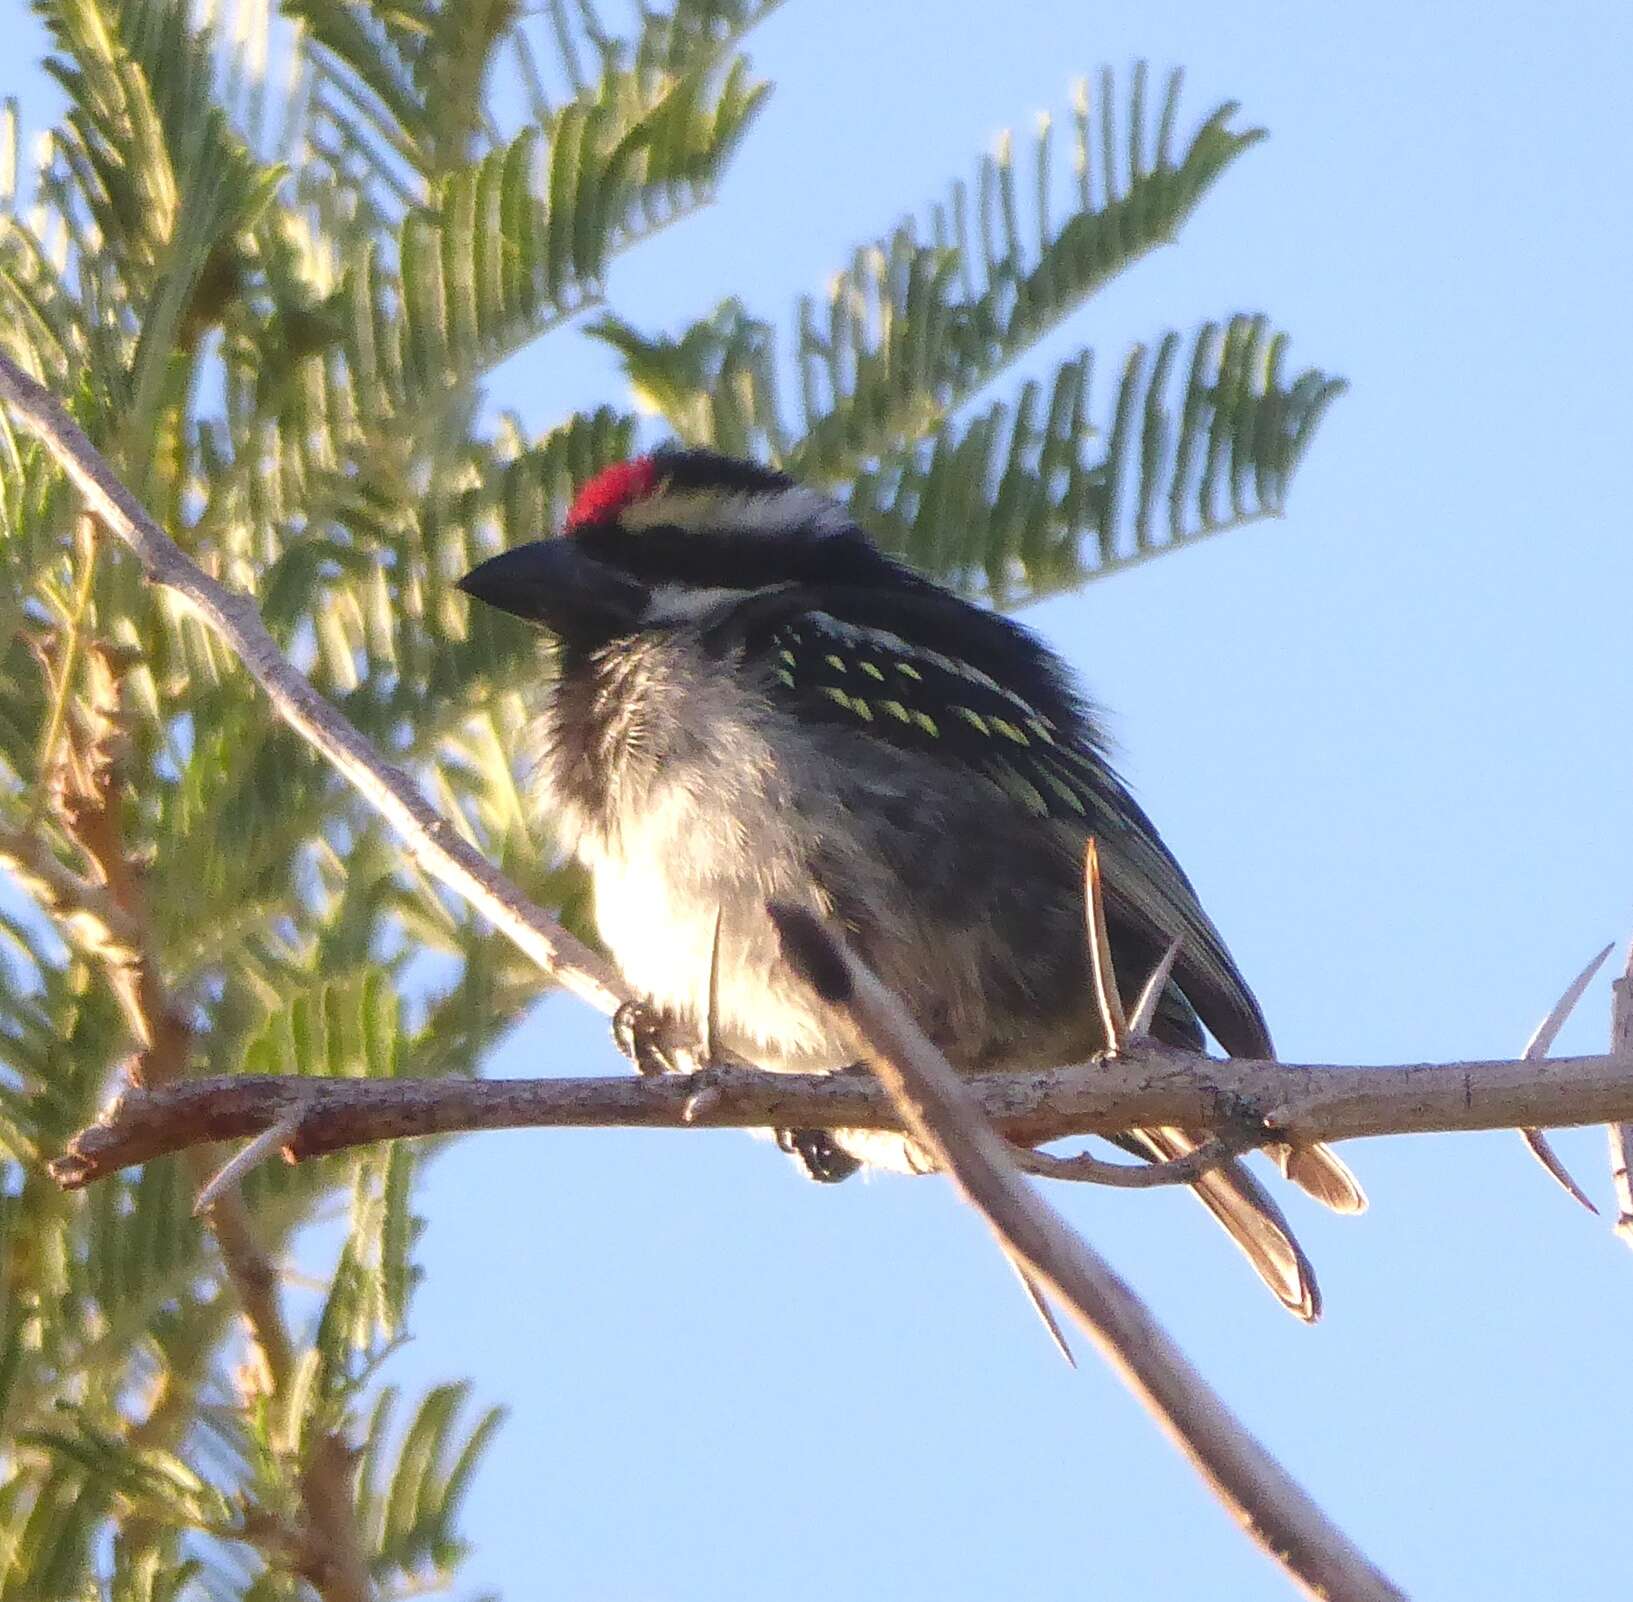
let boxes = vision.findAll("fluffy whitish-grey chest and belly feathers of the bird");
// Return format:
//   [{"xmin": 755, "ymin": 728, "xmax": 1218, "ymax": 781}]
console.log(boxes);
[{"xmin": 539, "ymin": 637, "xmax": 856, "ymax": 1068}]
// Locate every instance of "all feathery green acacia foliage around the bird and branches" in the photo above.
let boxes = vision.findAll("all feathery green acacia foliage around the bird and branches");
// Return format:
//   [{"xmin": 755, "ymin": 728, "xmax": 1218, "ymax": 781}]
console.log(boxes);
[{"xmin": 0, "ymin": 0, "xmax": 1337, "ymax": 1602}]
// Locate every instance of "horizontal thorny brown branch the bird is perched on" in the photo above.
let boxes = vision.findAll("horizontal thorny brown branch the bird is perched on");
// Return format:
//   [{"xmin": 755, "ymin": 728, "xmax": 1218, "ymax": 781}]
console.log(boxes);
[{"xmin": 51, "ymin": 1042, "xmax": 1633, "ymax": 1189}]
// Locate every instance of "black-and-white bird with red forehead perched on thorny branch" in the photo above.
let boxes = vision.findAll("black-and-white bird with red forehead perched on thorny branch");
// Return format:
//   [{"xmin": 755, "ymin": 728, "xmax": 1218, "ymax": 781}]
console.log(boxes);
[{"xmin": 461, "ymin": 449, "xmax": 1365, "ymax": 1319}]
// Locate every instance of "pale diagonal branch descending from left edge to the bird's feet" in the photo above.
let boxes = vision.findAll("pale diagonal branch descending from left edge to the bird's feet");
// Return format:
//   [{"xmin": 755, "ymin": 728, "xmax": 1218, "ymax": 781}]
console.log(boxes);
[{"xmin": 0, "ymin": 354, "xmax": 630, "ymax": 1014}]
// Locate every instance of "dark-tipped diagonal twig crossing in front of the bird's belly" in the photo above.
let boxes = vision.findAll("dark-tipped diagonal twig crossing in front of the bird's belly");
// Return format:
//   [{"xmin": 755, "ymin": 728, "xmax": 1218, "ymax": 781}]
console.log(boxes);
[{"xmin": 772, "ymin": 908, "xmax": 1404, "ymax": 1602}]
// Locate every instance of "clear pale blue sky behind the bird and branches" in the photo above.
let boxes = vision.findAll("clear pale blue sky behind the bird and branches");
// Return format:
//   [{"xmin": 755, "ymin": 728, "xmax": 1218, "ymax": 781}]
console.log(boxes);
[{"xmin": 12, "ymin": 0, "xmax": 1633, "ymax": 1602}]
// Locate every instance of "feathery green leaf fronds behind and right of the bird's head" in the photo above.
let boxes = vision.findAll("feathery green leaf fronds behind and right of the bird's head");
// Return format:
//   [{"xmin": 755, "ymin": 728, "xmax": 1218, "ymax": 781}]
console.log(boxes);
[{"xmin": 594, "ymin": 65, "xmax": 1341, "ymax": 604}]
